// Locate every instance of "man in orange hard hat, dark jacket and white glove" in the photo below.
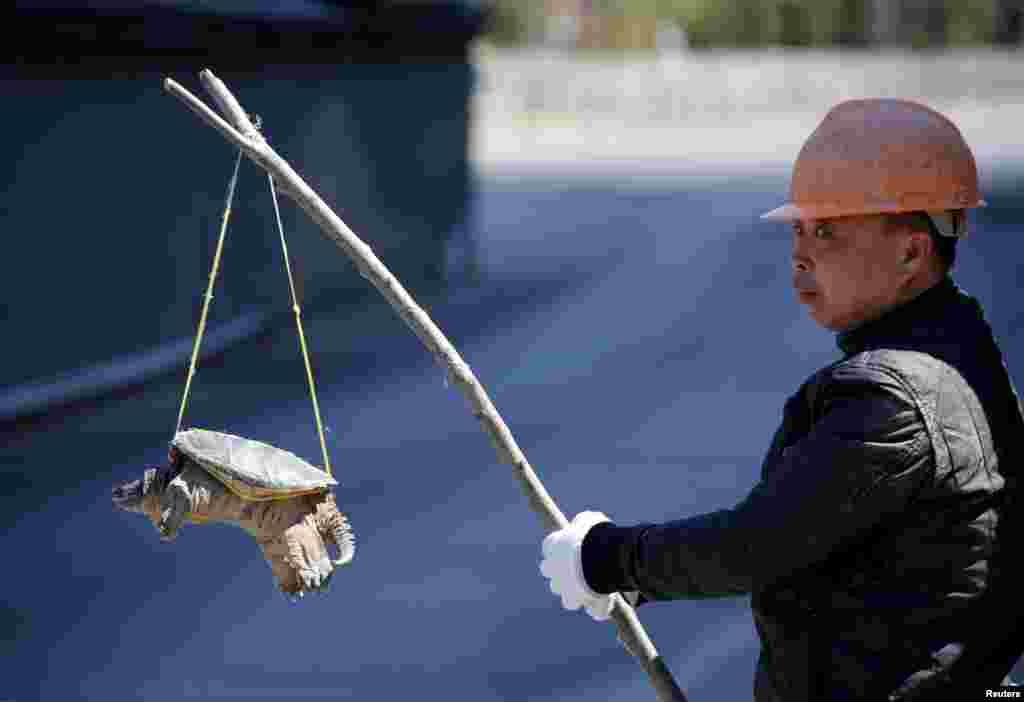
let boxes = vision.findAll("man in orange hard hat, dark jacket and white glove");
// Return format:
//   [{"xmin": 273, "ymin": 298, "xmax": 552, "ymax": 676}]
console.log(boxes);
[{"xmin": 541, "ymin": 99, "xmax": 1024, "ymax": 702}]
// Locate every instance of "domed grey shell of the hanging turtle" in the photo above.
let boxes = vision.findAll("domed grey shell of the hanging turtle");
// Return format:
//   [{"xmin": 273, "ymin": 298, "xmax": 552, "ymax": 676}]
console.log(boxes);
[{"xmin": 171, "ymin": 429, "xmax": 338, "ymax": 501}]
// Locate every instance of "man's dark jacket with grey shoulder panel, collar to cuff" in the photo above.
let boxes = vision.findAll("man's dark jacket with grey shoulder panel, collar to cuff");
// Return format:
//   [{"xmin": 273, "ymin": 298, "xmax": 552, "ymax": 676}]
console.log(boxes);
[{"xmin": 583, "ymin": 277, "xmax": 1024, "ymax": 702}]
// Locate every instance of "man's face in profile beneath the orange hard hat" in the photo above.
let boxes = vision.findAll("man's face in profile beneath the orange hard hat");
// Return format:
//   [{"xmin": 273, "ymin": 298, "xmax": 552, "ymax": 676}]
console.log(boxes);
[{"xmin": 793, "ymin": 215, "xmax": 909, "ymax": 332}]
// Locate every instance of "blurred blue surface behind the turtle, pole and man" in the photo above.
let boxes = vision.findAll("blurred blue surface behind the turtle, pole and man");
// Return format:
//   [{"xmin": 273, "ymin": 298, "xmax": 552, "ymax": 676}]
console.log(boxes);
[{"xmin": 0, "ymin": 166, "xmax": 1024, "ymax": 702}]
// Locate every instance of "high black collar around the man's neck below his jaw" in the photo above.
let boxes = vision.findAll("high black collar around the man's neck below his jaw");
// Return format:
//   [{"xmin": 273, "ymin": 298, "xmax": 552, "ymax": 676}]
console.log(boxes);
[{"xmin": 836, "ymin": 275, "xmax": 966, "ymax": 356}]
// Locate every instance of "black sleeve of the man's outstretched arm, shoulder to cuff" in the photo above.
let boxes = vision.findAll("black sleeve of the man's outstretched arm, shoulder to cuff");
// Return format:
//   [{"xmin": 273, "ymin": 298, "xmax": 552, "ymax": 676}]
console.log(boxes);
[{"xmin": 583, "ymin": 364, "xmax": 934, "ymax": 600}]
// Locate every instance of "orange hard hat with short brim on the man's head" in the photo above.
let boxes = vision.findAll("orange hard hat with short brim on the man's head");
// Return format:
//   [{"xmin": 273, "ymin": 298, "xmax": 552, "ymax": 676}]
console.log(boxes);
[{"xmin": 761, "ymin": 98, "xmax": 985, "ymax": 224}]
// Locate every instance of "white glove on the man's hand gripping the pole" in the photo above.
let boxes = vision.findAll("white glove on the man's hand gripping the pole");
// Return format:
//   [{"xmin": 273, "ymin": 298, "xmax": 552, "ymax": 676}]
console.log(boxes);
[{"xmin": 541, "ymin": 512, "xmax": 612, "ymax": 621}]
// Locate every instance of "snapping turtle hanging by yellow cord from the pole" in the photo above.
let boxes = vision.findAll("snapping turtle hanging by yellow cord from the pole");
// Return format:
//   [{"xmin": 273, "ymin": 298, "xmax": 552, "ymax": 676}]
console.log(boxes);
[{"xmin": 113, "ymin": 429, "xmax": 355, "ymax": 597}]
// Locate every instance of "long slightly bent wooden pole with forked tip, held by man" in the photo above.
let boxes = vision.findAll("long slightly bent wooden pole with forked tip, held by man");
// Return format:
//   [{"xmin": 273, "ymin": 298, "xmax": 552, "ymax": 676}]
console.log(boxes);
[{"xmin": 164, "ymin": 70, "xmax": 686, "ymax": 702}]
